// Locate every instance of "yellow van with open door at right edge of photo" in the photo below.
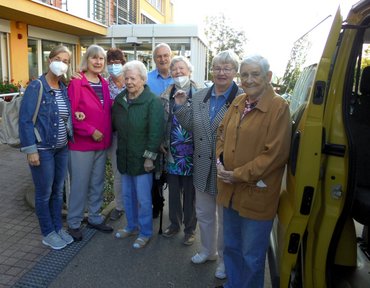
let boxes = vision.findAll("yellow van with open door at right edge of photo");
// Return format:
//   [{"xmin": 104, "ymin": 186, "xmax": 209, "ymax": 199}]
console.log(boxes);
[{"xmin": 268, "ymin": 0, "xmax": 370, "ymax": 288}]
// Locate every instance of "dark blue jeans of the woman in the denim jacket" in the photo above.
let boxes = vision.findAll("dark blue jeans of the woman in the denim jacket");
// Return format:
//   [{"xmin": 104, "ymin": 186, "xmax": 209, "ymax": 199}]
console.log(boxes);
[{"xmin": 30, "ymin": 146, "xmax": 68, "ymax": 236}]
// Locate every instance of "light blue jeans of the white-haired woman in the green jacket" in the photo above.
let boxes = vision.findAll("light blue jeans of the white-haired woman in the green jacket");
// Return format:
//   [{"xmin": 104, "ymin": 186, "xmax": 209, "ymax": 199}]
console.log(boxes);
[{"xmin": 122, "ymin": 173, "xmax": 153, "ymax": 238}]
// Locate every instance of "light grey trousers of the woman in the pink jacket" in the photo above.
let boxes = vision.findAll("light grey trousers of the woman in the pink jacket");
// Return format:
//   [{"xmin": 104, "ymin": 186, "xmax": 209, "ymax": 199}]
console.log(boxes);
[{"xmin": 67, "ymin": 150, "xmax": 107, "ymax": 228}]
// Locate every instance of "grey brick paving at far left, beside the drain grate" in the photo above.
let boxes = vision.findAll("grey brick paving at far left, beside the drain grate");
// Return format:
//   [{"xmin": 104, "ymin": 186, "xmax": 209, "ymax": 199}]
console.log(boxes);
[{"xmin": 0, "ymin": 144, "xmax": 50, "ymax": 288}]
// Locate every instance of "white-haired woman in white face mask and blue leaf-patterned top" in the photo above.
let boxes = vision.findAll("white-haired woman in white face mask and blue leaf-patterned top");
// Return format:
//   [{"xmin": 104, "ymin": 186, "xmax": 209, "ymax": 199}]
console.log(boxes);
[{"xmin": 160, "ymin": 56, "xmax": 198, "ymax": 245}]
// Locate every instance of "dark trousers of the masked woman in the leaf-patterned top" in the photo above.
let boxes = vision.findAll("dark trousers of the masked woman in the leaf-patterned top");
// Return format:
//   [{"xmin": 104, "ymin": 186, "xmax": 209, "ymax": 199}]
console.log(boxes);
[{"xmin": 167, "ymin": 174, "xmax": 197, "ymax": 234}]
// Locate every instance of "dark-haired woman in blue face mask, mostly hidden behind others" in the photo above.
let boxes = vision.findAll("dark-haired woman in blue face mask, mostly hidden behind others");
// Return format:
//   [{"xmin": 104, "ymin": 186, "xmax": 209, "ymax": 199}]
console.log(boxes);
[{"xmin": 107, "ymin": 48, "xmax": 126, "ymax": 220}]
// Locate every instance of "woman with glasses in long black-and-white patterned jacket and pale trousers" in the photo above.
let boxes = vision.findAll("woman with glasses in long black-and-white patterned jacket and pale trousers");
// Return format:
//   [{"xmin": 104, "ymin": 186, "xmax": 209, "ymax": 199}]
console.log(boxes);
[{"xmin": 175, "ymin": 51, "xmax": 243, "ymax": 279}]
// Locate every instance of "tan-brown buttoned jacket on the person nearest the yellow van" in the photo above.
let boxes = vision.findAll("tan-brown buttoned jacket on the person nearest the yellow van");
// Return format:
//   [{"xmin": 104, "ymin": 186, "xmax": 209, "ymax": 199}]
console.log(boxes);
[{"xmin": 216, "ymin": 86, "xmax": 291, "ymax": 220}]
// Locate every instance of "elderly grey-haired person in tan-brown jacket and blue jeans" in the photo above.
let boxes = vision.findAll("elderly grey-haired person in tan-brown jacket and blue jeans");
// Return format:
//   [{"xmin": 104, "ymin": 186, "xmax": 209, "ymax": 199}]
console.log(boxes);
[{"xmin": 216, "ymin": 55, "xmax": 291, "ymax": 288}]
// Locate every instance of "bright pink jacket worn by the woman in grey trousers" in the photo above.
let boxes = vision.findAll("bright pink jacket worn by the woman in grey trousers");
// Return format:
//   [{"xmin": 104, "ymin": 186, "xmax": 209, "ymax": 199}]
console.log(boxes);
[{"xmin": 68, "ymin": 74, "xmax": 112, "ymax": 151}]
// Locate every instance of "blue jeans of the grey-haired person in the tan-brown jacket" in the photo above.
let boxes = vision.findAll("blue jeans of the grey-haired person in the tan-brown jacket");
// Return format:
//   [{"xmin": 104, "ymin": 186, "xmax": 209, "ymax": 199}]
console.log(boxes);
[{"xmin": 223, "ymin": 208, "xmax": 273, "ymax": 288}]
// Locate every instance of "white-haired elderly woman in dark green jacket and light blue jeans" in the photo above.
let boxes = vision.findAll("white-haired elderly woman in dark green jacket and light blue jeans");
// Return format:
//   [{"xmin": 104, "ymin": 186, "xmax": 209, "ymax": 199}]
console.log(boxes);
[{"xmin": 112, "ymin": 60, "xmax": 164, "ymax": 249}]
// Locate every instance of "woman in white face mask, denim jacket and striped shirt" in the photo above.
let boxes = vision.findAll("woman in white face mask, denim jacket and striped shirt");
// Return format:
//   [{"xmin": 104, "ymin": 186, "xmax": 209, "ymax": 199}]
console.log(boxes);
[{"xmin": 19, "ymin": 45, "xmax": 73, "ymax": 250}]
